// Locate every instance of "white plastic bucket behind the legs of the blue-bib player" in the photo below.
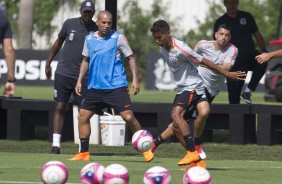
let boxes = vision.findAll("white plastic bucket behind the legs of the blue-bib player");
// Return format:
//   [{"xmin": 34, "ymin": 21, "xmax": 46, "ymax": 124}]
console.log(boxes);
[{"xmin": 100, "ymin": 113, "xmax": 126, "ymax": 146}]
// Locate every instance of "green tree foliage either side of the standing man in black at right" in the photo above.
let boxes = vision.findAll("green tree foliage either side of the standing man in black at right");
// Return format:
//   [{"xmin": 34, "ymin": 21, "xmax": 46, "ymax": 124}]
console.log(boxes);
[{"xmin": 183, "ymin": 0, "xmax": 281, "ymax": 48}]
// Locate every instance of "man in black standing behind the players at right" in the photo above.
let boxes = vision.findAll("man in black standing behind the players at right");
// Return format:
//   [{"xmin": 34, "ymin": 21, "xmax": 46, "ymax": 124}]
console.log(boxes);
[{"xmin": 214, "ymin": 0, "xmax": 267, "ymax": 104}]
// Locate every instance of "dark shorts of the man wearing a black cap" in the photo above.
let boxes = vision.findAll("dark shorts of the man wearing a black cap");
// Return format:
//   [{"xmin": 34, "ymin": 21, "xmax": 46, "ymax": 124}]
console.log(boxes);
[{"xmin": 54, "ymin": 74, "xmax": 87, "ymax": 106}]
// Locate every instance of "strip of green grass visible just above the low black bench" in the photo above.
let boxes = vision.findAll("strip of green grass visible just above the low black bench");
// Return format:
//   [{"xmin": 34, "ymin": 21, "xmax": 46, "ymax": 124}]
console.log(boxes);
[{"xmin": 15, "ymin": 83, "xmax": 281, "ymax": 105}]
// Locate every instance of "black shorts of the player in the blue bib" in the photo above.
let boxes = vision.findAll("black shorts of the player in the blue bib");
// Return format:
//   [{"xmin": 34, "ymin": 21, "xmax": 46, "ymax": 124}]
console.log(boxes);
[{"xmin": 81, "ymin": 86, "xmax": 132, "ymax": 115}]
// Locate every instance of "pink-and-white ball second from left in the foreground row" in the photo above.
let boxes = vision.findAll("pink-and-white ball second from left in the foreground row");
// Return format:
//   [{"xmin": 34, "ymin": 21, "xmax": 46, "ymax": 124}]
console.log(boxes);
[{"xmin": 80, "ymin": 163, "xmax": 105, "ymax": 184}]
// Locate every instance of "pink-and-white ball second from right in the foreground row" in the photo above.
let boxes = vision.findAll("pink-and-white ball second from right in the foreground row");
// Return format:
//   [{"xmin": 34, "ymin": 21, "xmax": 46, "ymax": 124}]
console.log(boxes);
[{"xmin": 143, "ymin": 166, "xmax": 171, "ymax": 184}]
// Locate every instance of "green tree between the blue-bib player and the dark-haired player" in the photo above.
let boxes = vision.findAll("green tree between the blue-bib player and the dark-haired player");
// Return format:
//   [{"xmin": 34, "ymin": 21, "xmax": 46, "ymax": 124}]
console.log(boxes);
[{"xmin": 117, "ymin": 0, "xmax": 180, "ymax": 80}]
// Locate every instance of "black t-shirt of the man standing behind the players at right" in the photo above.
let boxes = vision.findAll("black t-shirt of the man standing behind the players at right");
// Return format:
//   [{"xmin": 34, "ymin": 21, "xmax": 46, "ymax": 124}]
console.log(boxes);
[{"xmin": 214, "ymin": 11, "xmax": 258, "ymax": 55}]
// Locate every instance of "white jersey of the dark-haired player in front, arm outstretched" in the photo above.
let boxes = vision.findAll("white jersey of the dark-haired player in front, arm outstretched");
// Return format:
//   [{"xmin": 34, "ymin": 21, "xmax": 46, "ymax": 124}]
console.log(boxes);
[{"xmin": 161, "ymin": 38, "xmax": 204, "ymax": 95}]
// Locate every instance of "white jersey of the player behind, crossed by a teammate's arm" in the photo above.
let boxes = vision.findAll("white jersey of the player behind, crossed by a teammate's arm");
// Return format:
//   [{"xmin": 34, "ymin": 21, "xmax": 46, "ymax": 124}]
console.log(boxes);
[{"xmin": 194, "ymin": 40, "xmax": 238, "ymax": 96}]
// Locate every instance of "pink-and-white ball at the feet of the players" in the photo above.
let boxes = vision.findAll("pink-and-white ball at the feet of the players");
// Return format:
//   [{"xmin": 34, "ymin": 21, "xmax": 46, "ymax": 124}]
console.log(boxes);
[{"xmin": 132, "ymin": 130, "xmax": 154, "ymax": 152}]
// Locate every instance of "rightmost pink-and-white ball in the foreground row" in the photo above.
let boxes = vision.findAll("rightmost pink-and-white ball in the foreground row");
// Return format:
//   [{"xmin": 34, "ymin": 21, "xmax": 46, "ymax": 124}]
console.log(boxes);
[{"xmin": 183, "ymin": 166, "xmax": 211, "ymax": 184}]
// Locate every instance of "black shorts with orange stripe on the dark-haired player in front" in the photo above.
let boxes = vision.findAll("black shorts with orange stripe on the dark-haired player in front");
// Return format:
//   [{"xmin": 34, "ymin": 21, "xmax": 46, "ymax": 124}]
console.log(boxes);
[{"xmin": 173, "ymin": 91, "xmax": 202, "ymax": 117}]
